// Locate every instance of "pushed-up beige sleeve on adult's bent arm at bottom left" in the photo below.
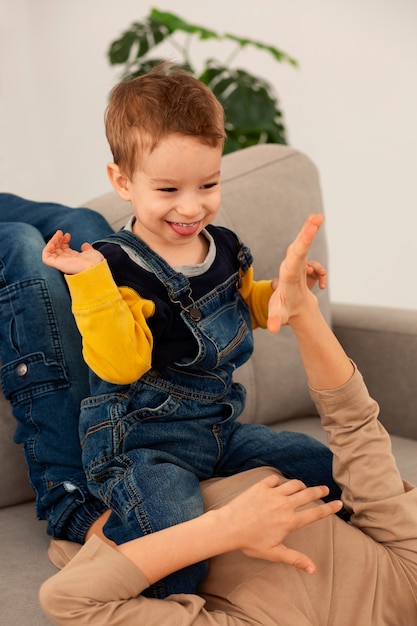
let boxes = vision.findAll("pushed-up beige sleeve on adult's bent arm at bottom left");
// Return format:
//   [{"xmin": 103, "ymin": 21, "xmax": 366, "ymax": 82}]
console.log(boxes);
[{"xmin": 40, "ymin": 536, "xmax": 252, "ymax": 626}]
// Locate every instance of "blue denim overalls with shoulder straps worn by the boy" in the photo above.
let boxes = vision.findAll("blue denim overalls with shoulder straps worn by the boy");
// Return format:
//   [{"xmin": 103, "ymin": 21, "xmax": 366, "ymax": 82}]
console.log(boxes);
[{"xmin": 80, "ymin": 231, "xmax": 340, "ymax": 597}]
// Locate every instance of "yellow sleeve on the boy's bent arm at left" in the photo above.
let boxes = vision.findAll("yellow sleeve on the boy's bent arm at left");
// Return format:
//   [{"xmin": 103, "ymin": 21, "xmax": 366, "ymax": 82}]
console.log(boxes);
[{"xmin": 65, "ymin": 260, "xmax": 155, "ymax": 384}]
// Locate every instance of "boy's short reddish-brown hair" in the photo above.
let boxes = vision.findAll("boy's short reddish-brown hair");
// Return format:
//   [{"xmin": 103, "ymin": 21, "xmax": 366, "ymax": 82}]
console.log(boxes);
[{"xmin": 105, "ymin": 63, "xmax": 226, "ymax": 179}]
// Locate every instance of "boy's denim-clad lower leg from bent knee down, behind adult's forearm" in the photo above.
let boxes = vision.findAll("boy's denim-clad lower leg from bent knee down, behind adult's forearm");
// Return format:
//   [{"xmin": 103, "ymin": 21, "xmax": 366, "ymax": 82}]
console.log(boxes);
[{"xmin": 98, "ymin": 449, "xmax": 208, "ymax": 598}]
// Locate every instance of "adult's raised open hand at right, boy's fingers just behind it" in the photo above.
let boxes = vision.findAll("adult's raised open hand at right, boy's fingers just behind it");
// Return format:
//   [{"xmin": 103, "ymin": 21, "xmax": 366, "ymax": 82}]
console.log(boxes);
[{"xmin": 267, "ymin": 214, "xmax": 326, "ymax": 333}]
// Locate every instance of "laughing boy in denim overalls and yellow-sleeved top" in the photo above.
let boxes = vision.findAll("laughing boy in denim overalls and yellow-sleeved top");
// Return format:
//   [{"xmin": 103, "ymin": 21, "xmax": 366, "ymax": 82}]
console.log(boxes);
[{"xmin": 43, "ymin": 65, "xmax": 340, "ymax": 597}]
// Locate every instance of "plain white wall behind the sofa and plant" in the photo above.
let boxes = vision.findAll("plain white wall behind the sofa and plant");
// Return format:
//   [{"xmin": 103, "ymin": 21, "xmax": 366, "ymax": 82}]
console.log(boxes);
[{"xmin": 0, "ymin": 0, "xmax": 417, "ymax": 309}]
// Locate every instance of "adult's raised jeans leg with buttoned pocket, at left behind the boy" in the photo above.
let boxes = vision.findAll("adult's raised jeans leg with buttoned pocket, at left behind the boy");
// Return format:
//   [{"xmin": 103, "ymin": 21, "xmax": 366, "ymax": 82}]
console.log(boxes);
[{"xmin": 0, "ymin": 193, "xmax": 112, "ymax": 543}]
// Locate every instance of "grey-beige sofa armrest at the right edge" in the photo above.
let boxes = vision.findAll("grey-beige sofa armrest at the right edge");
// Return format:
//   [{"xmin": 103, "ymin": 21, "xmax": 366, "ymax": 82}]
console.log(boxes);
[{"xmin": 332, "ymin": 304, "xmax": 417, "ymax": 439}]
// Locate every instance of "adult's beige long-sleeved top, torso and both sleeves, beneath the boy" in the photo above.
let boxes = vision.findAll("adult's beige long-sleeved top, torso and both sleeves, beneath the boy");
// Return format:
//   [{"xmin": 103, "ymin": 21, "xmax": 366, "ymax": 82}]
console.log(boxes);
[{"xmin": 40, "ymin": 372, "xmax": 417, "ymax": 626}]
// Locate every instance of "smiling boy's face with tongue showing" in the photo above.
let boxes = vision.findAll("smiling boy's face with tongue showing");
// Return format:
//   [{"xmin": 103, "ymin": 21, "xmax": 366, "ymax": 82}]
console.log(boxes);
[{"xmin": 115, "ymin": 133, "xmax": 222, "ymax": 265}]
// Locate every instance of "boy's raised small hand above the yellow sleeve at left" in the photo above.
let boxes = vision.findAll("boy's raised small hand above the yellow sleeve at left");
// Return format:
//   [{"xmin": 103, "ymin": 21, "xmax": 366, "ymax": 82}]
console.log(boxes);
[{"xmin": 42, "ymin": 230, "xmax": 104, "ymax": 274}]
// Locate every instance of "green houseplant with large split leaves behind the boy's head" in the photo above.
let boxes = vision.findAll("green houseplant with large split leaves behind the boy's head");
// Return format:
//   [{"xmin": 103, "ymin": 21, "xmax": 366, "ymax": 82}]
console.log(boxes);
[{"xmin": 108, "ymin": 9, "xmax": 297, "ymax": 153}]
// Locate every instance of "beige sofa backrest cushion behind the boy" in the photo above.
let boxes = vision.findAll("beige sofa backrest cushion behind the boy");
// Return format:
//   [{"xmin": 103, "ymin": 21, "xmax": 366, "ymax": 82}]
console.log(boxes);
[{"xmin": 0, "ymin": 144, "xmax": 330, "ymax": 506}]
